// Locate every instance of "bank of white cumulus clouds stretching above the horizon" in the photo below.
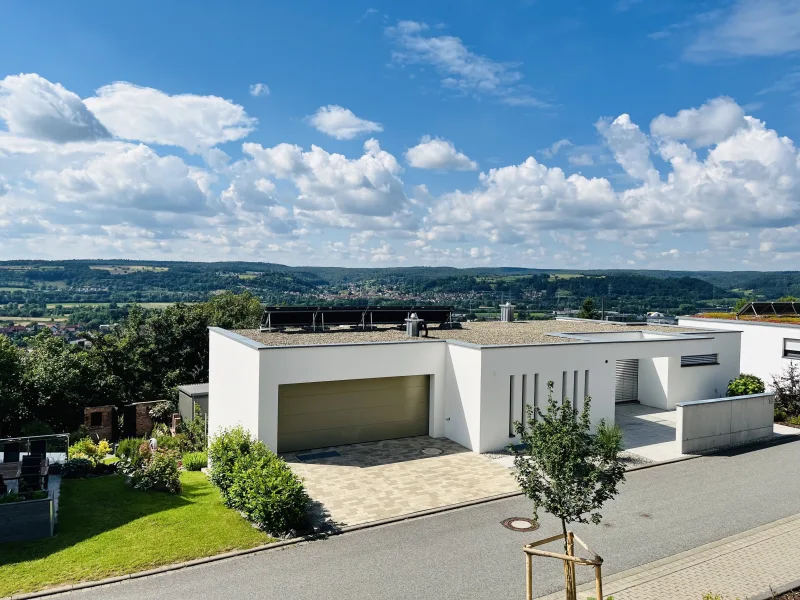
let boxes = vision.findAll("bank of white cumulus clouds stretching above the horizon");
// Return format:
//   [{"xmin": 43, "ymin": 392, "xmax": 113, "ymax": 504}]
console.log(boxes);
[{"xmin": 0, "ymin": 69, "xmax": 800, "ymax": 268}]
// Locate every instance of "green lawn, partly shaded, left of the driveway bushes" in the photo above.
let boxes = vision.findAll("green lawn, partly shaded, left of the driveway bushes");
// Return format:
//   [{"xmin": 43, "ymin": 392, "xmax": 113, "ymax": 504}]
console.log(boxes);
[{"xmin": 0, "ymin": 472, "xmax": 274, "ymax": 597}]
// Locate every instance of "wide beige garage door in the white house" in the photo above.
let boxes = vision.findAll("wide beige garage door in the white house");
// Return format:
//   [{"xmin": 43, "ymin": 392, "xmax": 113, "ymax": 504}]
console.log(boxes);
[{"xmin": 278, "ymin": 375, "xmax": 430, "ymax": 452}]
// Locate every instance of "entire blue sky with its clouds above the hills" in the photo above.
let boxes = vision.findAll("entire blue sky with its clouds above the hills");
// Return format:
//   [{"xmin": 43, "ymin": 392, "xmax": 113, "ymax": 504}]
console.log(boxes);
[{"xmin": 0, "ymin": 0, "xmax": 800, "ymax": 269}]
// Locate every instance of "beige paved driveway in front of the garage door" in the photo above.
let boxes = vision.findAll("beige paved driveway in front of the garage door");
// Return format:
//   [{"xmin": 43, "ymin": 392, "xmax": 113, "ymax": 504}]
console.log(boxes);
[{"xmin": 283, "ymin": 436, "xmax": 519, "ymax": 526}]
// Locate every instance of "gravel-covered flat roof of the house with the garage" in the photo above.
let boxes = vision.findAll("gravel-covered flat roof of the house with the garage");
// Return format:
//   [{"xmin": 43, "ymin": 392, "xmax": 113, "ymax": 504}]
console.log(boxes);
[{"xmin": 234, "ymin": 319, "xmax": 708, "ymax": 347}]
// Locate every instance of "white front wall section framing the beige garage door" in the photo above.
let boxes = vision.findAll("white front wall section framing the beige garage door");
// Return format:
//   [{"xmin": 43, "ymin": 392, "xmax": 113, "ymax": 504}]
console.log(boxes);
[{"xmin": 258, "ymin": 341, "xmax": 447, "ymax": 448}]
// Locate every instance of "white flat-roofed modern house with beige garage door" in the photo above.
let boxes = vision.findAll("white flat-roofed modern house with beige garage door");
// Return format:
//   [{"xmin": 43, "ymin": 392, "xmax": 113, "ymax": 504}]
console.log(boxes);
[{"xmin": 209, "ymin": 319, "xmax": 740, "ymax": 452}]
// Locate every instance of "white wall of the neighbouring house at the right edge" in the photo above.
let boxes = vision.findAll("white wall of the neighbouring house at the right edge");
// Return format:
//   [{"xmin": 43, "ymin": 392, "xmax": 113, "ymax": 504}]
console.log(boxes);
[{"xmin": 678, "ymin": 317, "xmax": 800, "ymax": 388}]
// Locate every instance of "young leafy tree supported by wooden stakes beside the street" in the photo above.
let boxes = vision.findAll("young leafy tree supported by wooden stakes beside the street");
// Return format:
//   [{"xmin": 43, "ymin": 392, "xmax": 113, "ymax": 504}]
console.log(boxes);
[{"xmin": 514, "ymin": 381, "xmax": 625, "ymax": 598}]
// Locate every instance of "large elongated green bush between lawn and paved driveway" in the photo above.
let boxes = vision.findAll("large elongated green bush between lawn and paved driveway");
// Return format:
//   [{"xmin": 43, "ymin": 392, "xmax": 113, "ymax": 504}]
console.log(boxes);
[{"xmin": 208, "ymin": 427, "xmax": 308, "ymax": 535}]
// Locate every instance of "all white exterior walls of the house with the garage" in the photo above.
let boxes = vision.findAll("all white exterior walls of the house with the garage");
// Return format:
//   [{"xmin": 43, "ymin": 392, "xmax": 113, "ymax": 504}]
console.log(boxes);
[{"xmin": 209, "ymin": 328, "xmax": 739, "ymax": 452}]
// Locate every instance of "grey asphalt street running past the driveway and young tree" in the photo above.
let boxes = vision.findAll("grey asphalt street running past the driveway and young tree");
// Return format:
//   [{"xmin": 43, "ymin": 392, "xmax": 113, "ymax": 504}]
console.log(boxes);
[{"xmin": 48, "ymin": 441, "xmax": 800, "ymax": 600}]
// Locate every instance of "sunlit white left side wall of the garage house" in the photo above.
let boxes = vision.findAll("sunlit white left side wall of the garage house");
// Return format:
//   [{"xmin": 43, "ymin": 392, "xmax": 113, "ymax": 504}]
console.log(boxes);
[{"xmin": 208, "ymin": 329, "xmax": 260, "ymax": 436}]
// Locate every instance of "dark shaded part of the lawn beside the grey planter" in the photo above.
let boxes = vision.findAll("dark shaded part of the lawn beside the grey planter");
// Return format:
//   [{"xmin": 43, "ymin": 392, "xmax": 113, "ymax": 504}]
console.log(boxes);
[{"xmin": 0, "ymin": 475, "xmax": 192, "ymax": 566}]
